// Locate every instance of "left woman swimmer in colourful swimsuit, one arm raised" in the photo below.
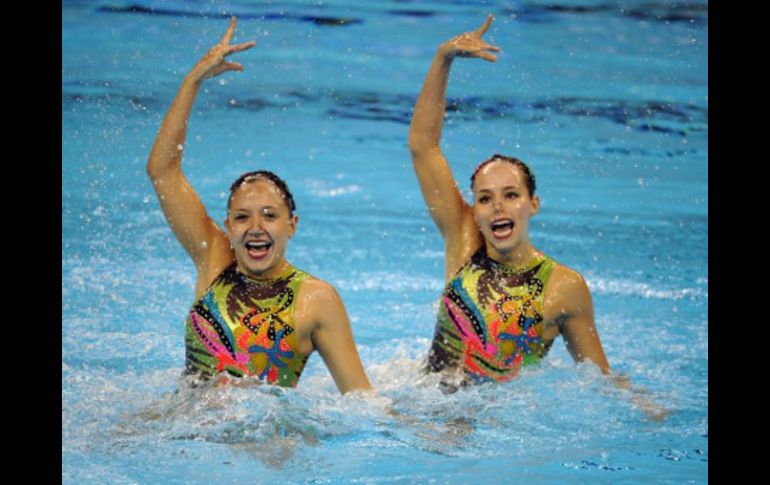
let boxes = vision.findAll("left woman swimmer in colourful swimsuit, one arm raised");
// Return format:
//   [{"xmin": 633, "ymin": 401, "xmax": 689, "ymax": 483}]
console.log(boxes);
[{"xmin": 147, "ymin": 18, "xmax": 371, "ymax": 393}]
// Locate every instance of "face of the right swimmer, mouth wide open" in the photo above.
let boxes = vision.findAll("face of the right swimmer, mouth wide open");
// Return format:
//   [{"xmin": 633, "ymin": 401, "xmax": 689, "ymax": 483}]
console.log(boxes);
[{"xmin": 473, "ymin": 161, "xmax": 540, "ymax": 256}]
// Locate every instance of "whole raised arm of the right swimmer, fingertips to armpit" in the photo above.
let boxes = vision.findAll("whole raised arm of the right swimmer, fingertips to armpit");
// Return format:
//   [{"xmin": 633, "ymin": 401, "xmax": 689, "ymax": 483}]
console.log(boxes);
[{"xmin": 409, "ymin": 15, "xmax": 500, "ymax": 273}]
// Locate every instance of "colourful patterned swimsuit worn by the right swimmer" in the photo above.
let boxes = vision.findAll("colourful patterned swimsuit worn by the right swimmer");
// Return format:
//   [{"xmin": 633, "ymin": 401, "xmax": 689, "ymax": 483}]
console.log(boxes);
[{"xmin": 426, "ymin": 247, "xmax": 556, "ymax": 384}]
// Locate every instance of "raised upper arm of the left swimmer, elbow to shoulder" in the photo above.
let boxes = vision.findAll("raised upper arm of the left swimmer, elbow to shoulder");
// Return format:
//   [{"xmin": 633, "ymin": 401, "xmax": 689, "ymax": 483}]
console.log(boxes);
[{"xmin": 148, "ymin": 167, "xmax": 227, "ymax": 273}]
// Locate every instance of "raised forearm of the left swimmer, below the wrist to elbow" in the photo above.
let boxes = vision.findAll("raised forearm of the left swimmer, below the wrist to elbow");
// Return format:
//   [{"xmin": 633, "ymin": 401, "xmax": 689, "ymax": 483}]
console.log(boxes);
[{"xmin": 147, "ymin": 75, "xmax": 200, "ymax": 178}]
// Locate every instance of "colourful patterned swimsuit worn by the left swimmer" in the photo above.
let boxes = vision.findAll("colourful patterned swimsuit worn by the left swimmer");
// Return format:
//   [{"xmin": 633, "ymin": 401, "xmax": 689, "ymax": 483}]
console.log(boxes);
[{"xmin": 185, "ymin": 263, "xmax": 310, "ymax": 387}]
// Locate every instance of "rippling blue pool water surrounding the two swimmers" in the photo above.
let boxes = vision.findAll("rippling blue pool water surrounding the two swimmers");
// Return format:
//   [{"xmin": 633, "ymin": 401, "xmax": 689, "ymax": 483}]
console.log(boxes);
[{"xmin": 62, "ymin": 0, "xmax": 708, "ymax": 483}]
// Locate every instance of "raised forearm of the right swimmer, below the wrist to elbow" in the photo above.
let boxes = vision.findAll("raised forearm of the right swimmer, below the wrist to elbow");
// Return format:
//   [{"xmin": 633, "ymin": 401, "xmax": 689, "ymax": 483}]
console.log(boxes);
[{"xmin": 409, "ymin": 50, "xmax": 453, "ymax": 154}]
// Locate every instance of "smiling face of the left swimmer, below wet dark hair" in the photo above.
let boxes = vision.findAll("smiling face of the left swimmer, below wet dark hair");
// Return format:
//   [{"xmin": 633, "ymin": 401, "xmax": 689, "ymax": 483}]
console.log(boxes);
[{"xmin": 225, "ymin": 179, "xmax": 297, "ymax": 278}]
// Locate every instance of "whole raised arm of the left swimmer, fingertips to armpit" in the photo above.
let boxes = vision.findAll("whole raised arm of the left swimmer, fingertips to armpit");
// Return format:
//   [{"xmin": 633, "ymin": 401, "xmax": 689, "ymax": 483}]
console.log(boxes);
[{"xmin": 147, "ymin": 17, "xmax": 256, "ymax": 274}]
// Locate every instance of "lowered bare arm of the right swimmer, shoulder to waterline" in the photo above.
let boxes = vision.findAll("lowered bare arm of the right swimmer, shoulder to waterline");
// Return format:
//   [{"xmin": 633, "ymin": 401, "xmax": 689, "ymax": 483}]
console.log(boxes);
[{"xmin": 548, "ymin": 266, "xmax": 610, "ymax": 374}]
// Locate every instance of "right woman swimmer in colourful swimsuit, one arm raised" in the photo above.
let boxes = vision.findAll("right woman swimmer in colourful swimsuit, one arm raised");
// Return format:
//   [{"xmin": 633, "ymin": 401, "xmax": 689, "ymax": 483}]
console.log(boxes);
[{"xmin": 409, "ymin": 16, "xmax": 609, "ymax": 388}]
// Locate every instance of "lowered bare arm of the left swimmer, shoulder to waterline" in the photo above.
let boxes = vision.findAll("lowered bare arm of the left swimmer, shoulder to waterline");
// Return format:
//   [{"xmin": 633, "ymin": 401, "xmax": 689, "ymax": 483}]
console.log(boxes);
[{"xmin": 302, "ymin": 280, "xmax": 372, "ymax": 394}]
